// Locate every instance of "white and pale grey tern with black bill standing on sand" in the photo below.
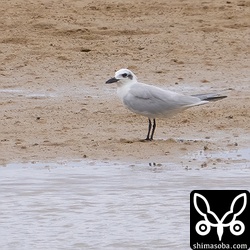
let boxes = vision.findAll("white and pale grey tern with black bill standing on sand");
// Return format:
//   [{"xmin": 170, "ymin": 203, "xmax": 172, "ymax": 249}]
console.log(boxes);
[{"xmin": 106, "ymin": 69, "xmax": 226, "ymax": 140}]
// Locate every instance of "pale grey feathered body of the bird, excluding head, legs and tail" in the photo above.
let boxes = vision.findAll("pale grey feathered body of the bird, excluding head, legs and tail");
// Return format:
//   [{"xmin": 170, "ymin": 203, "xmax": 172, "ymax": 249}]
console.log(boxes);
[{"xmin": 123, "ymin": 84, "xmax": 202, "ymax": 118}]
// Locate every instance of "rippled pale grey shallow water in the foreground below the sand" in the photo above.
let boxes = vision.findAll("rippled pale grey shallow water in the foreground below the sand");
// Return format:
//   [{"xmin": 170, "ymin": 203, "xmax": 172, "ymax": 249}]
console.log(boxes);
[{"xmin": 0, "ymin": 162, "xmax": 250, "ymax": 250}]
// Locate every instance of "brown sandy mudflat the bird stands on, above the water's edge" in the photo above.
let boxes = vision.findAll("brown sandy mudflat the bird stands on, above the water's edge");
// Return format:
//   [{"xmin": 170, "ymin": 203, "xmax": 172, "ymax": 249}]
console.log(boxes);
[{"xmin": 0, "ymin": 0, "xmax": 250, "ymax": 166}]
